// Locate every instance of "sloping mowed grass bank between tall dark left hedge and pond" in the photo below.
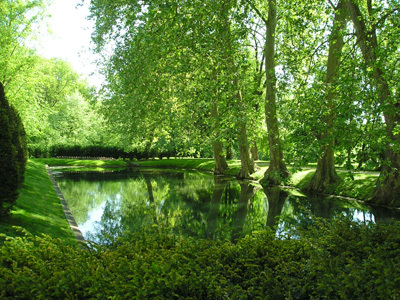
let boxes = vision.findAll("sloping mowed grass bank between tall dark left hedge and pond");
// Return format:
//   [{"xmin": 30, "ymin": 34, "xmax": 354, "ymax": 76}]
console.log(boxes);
[{"xmin": 0, "ymin": 160, "xmax": 75, "ymax": 242}]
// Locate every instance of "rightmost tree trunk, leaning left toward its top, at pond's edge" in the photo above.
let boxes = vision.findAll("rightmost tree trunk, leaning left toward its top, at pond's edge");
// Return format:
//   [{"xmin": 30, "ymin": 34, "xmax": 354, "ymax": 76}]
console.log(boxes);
[{"xmin": 347, "ymin": 0, "xmax": 400, "ymax": 206}]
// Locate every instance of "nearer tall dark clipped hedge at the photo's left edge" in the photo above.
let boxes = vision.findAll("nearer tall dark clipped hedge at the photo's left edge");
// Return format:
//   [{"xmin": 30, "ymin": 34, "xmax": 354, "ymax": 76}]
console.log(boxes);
[{"xmin": 0, "ymin": 82, "xmax": 18, "ymax": 216}]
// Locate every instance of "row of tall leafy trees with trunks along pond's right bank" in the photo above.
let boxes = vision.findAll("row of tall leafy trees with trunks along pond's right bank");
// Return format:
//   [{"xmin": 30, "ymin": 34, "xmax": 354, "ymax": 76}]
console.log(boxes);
[{"xmin": 90, "ymin": 0, "xmax": 400, "ymax": 205}]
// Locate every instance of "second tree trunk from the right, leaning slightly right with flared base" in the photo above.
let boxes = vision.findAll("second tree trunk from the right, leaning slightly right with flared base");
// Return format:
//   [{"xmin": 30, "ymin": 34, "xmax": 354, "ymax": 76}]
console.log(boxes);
[{"xmin": 305, "ymin": 0, "xmax": 346, "ymax": 192}]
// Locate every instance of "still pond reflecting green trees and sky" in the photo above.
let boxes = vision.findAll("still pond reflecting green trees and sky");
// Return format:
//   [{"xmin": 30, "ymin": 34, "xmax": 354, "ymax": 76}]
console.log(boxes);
[{"xmin": 53, "ymin": 168, "xmax": 399, "ymax": 244}]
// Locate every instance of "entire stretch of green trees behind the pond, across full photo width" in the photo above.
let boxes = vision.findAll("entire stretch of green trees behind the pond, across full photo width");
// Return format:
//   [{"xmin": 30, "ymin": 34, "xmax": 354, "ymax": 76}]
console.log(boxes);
[{"xmin": 0, "ymin": 0, "xmax": 400, "ymax": 206}]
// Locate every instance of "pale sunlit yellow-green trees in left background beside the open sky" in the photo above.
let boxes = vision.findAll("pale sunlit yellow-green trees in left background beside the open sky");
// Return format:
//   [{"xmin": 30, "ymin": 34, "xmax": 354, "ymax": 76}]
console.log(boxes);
[{"xmin": 0, "ymin": 0, "xmax": 110, "ymax": 157}]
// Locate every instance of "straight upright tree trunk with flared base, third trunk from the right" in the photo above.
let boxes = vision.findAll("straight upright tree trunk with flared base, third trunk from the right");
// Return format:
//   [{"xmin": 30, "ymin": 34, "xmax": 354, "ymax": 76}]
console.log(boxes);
[{"xmin": 262, "ymin": 0, "xmax": 289, "ymax": 185}]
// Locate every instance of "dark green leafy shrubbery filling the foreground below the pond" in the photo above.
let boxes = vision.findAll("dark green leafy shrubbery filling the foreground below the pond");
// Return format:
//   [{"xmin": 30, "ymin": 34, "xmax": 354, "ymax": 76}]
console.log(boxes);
[{"xmin": 0, "ymin": 220, "xmax": 400, "ymax": 299}]
